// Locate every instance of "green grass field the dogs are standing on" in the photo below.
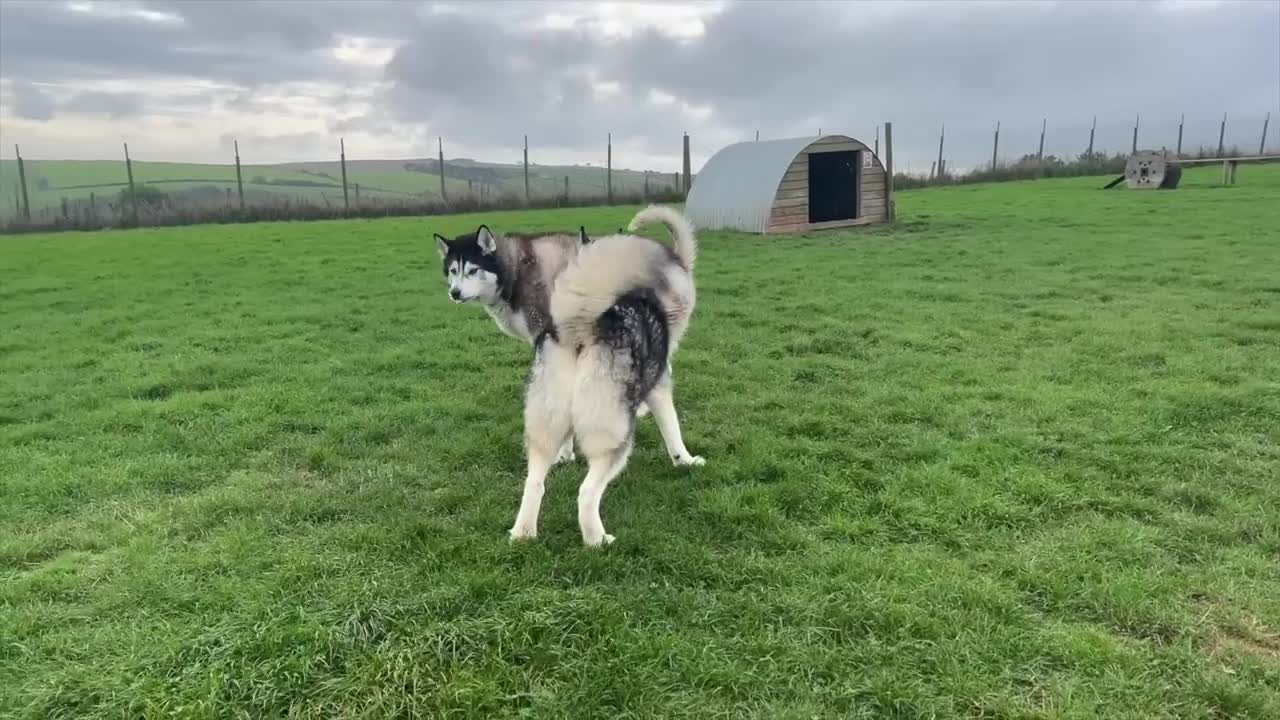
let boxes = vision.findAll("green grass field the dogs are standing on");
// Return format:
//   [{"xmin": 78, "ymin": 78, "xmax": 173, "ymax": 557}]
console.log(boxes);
[{"xmin": 0, "ymin": 167, "xmax": 1280, "ymax": 719}]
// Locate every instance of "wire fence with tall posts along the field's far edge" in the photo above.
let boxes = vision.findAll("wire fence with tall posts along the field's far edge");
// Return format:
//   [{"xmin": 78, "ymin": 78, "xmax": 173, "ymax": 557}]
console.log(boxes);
[{"xmin": 0, "ymin": 113, "xmax": 1271, "ymax": 233}]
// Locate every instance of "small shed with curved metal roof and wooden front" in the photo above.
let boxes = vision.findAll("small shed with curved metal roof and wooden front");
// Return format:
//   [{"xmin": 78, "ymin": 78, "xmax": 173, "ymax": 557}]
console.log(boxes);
[{"xmin": 685, "ymin": 135, "xmax": 888, "ymax": 233}]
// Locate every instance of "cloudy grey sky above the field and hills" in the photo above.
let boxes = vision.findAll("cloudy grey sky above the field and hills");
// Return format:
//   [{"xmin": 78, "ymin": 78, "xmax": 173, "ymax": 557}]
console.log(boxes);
[{"xmin": 0, "ymin": 0, "xmax": 1280, "ymax": 172}]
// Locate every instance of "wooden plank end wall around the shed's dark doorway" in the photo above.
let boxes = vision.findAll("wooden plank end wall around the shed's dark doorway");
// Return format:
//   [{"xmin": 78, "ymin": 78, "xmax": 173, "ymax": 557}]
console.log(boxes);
[{"xmin": 768, "ymin": 136, "xmax": 887, "ymax": 233}]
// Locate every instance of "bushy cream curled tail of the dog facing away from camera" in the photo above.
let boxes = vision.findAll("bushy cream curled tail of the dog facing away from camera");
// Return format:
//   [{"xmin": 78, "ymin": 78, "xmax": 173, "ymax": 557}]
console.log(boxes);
[{"xmin": 550, "ymin": 234, "xmax": 671, "ymax": 347}]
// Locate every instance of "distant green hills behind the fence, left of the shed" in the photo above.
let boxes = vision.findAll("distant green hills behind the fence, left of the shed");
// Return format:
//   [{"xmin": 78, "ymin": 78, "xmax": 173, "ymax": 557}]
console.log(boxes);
[{"xmin": 0, "ymin": 159, "xmax": 673, "ymax": 217}]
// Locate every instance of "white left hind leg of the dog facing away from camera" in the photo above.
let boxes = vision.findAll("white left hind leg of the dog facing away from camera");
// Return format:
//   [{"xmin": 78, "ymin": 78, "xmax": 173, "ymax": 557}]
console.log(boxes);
[{"xmin": 511, "ymin": 341, "xmax": 572, "ymax": 539}]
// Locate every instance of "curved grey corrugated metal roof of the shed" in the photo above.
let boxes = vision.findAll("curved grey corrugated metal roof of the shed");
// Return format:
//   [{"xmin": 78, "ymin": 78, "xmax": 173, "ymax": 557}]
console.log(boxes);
[{"xmin": 685, "ymin": 136, "xmax": 824, "ymax": 233}]
